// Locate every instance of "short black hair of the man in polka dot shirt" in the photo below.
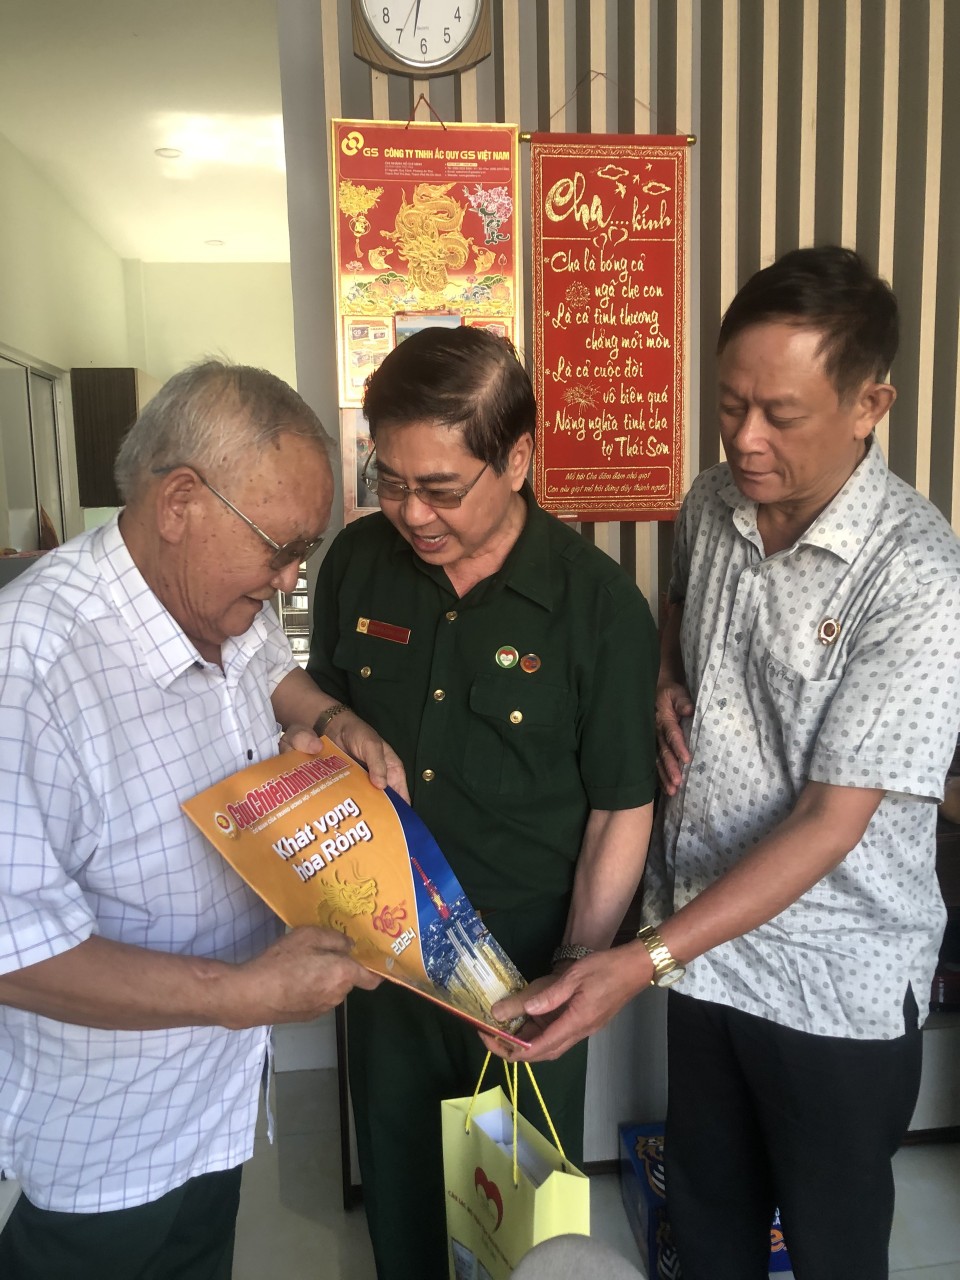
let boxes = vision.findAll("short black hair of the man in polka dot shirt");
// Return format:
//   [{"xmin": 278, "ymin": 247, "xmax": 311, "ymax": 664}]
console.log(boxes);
[{"xmin": 717, "ymin": 244, "xmax": 900, "ymax": 401}]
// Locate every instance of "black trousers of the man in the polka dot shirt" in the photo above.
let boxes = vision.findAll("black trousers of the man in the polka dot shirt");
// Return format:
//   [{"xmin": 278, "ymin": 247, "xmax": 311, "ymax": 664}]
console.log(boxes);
[{"xmin": 664, "ymin": 991, "xmax": 922, "ymax": 1280}]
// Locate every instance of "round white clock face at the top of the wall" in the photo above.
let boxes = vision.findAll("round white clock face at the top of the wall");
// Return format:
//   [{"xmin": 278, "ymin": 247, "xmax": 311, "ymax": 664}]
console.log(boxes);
[{"xmin": 360, "ymin": 0, "xmax": 483, "ymax": 70}]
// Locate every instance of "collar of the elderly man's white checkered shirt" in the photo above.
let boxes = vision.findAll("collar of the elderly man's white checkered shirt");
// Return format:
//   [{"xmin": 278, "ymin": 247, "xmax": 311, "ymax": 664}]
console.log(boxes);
[{"xmin": 92, "ymin": 515, "xmax": 266, "ymax": 689}]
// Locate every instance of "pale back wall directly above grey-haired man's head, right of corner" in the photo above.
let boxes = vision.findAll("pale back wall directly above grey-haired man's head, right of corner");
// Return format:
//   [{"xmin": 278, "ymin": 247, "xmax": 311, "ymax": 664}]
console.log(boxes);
[{"xmin": 136, "ymin": 262, "xmax": 297, "ymax": 387}]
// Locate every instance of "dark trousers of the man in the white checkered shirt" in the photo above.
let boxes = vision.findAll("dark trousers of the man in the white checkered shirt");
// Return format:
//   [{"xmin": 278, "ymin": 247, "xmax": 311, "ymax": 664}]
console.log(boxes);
[{"xmin": 0, "ymin": 1165, "xmax": 242, "ymax": 1280}]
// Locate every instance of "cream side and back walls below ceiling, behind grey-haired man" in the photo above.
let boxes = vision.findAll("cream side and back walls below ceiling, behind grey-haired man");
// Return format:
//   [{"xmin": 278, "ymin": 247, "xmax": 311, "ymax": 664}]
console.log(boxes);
[{"xmin": 0, "ymin": 134, "xmax": 296, "ymax": 385}]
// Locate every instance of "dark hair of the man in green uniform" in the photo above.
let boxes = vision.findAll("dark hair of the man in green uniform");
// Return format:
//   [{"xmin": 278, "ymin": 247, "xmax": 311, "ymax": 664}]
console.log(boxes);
[{"xmin": 364, "ymin": 325, "xmax": 536, "ymax": 475}]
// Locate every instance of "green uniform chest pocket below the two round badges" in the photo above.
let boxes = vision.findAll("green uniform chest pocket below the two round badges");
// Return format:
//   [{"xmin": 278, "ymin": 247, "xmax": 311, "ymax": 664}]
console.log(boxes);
[{"xmin": 463, "ymin": 673, "xmax": 576, "ymax": 795}]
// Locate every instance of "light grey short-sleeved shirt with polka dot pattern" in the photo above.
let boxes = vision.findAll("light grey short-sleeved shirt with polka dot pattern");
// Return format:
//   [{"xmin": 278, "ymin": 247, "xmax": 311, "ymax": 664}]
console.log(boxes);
[{"xmin": 644, "ymin": 440, "xmax": 960, "ymax": 1039}]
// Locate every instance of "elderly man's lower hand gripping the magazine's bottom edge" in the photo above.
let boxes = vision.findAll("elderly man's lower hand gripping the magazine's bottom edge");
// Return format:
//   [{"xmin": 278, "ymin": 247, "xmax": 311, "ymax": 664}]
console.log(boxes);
[{"xmin": 223, "ymin": 925, "xmax": 383, "ymax": 1029}]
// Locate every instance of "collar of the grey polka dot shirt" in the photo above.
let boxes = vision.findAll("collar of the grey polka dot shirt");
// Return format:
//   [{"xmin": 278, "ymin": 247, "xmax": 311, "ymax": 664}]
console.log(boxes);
[{"xmin": 719, "ymin": 435, "xmax": 887, "ymax": 563}]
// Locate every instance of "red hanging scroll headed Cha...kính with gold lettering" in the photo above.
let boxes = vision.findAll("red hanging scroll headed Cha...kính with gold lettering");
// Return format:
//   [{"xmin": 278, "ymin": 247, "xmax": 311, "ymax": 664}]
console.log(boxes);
[{"xmin": 531, "ymin": 133, "xmax": 689, "ymax": 520}]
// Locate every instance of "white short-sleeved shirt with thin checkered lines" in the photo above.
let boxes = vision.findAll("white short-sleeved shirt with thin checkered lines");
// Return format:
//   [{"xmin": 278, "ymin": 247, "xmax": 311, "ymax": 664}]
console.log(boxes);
[{"xmin": 0, "ymin": 518, "xmax": 294, "ymax": 1212}]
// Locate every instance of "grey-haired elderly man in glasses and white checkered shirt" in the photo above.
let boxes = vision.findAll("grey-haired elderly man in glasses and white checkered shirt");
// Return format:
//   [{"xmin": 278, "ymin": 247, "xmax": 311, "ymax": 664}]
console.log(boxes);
[{"xmin": 0, "ymin": 362, "xmax": 403, "ymax": 1280}]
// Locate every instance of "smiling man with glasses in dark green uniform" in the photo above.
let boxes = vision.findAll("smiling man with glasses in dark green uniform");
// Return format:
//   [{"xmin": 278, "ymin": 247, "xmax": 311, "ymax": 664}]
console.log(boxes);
[{"xmin": 307, "ymin": 326, "xmax": 657, "ymax": 1280}]
